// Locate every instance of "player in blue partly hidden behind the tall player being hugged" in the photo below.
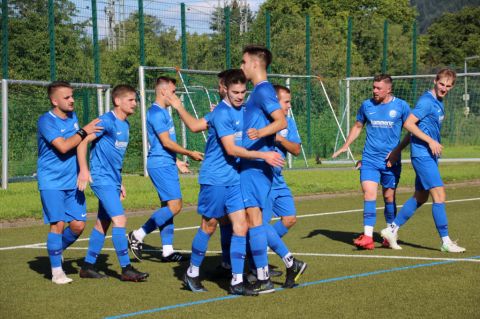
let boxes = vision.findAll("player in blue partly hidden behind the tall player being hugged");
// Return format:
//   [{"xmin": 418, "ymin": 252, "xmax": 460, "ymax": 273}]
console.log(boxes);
[{"xmin": 263, "ymin": 85, "xmax": 307, "ymax": 288}]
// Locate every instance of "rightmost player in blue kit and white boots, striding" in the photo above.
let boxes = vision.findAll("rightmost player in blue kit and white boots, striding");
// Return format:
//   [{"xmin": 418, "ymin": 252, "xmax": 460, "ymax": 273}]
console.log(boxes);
[{"xmin": 381, "ymin": 68, "xmax": 465, "ymax": 253}]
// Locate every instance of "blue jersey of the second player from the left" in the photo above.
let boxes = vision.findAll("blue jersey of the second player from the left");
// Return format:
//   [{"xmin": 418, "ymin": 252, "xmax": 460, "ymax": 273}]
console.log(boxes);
[{"xmin": 90, "ymin": 111, "xmax": 130, "ymax": 188}]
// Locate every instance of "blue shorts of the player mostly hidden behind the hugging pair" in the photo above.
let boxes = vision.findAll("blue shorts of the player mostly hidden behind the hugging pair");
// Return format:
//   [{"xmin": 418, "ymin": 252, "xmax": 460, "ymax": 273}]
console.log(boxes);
[{"xmin": 262, "ymin": 186, "xmax": 297, "ymax": 223}]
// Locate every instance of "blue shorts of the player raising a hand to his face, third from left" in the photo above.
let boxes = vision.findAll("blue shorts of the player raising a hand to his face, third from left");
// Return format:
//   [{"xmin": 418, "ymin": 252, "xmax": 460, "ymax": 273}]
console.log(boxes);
[{"xmin": 148, "ymin": 165, "xmax": 182, "ymax": 202}]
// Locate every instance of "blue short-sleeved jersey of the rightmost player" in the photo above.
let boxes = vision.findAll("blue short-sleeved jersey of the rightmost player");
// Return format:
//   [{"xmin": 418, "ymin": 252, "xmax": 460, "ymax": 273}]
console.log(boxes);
[{"xmin": 410, "ymin": 91, "xmax": 445, "ymax": 157}]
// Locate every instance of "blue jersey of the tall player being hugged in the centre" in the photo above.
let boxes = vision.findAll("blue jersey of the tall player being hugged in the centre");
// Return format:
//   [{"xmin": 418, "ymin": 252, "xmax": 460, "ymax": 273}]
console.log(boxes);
[{"xmin": 242, "ymin": 81, "xmax": 280, "ymax": 152}]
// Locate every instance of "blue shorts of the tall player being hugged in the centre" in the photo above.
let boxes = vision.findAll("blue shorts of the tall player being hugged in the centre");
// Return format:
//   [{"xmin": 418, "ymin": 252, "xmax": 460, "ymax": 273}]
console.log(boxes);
[{"xmin": 240, "ymin": 161, "xmax": 273, "ymax": 209}]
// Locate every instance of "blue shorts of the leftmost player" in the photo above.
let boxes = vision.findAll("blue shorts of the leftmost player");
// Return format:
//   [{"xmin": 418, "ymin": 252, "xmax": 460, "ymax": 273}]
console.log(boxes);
[{"xmin": 40, "ymin": 189, "xmax": 87, "ymax": 224}]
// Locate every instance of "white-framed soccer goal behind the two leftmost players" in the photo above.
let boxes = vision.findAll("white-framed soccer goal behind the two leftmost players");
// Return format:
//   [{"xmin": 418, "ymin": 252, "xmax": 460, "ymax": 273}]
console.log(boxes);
[{"xmin": 1, "ymin": 79, "xmax": 110, "ymax": 189}]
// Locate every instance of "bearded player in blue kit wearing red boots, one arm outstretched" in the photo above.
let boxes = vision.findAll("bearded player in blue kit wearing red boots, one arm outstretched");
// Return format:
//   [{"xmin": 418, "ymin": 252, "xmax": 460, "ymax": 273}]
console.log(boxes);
[{"xmin": 332, "ymin": 74, "xmax": 410, "ymax": 249}]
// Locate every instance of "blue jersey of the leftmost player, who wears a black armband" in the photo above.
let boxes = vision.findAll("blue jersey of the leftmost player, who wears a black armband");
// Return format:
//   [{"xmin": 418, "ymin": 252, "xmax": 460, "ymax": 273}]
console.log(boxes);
[{"xmin": 37, "ymin": 111, "xmax": 78, "ymax": 190}]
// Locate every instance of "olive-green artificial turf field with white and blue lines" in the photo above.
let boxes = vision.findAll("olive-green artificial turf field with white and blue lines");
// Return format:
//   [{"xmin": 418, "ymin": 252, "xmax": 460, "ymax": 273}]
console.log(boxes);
[{"xmin": 0, "ymin": 183, "xmax": 480, "ymax": 319}]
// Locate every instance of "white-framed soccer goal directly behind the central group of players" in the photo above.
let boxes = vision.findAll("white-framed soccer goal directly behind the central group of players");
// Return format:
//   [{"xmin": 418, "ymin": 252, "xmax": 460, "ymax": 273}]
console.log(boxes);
[{"xmin": 139, "ymin": 66, "xmax": 344, "ymax": 176}]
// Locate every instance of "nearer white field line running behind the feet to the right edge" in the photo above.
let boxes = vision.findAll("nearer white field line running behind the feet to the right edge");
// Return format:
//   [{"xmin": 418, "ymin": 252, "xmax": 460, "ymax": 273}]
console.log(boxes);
[{"xmin": 18, "ymin": 246, "xmax": 480, "ymax": 263}]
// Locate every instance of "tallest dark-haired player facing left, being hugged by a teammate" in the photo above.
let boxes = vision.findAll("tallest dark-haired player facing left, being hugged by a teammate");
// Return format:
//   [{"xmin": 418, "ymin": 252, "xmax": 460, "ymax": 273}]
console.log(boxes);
[{"xmin": 240, "ymin": 45, "xmax": 287, "ymax": 293}]
